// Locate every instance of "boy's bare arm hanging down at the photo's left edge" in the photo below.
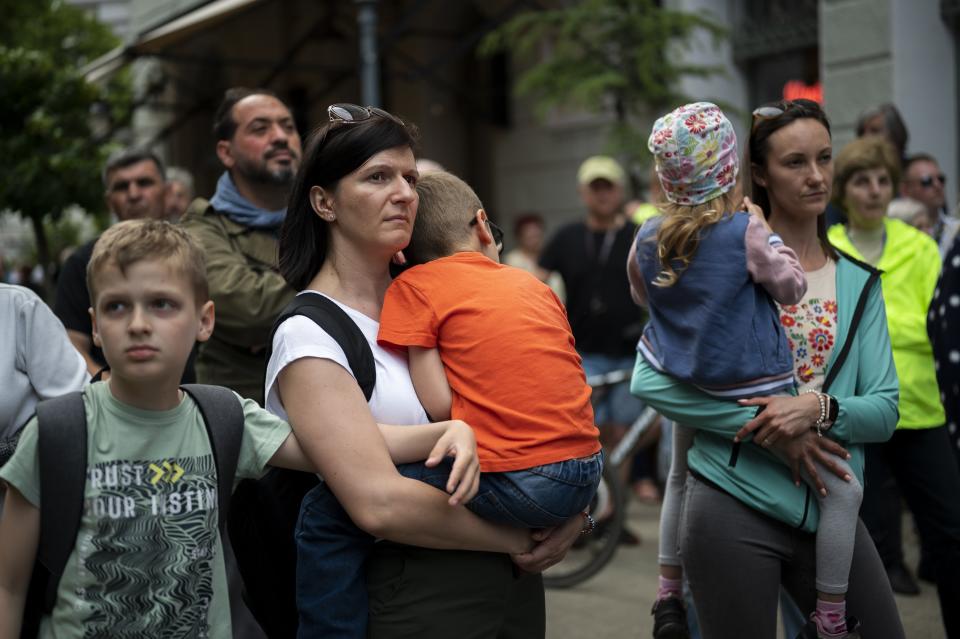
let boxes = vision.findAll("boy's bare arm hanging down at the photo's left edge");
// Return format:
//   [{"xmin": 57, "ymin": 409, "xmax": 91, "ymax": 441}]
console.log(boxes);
[{"xmin": 0, "ymin": 485, "xmax": 40, "ymax": 639}]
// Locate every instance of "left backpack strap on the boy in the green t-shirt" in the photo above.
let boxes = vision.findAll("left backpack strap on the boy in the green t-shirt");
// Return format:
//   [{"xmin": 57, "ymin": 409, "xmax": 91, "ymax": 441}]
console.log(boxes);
[{"xmin": 37, "ymin": 391, "xmax": 87, "ymax": 613}]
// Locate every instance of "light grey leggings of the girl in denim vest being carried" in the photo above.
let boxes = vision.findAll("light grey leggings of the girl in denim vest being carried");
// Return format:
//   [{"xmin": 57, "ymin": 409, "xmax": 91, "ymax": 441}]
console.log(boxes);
[{"xmin": 659, "ymin": 423, "xmax": 863, "ymax": 595}]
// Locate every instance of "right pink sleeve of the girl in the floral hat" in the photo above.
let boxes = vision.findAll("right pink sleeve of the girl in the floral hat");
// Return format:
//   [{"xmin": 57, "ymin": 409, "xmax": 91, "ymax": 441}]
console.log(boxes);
[{"xmin": 744, "ymin": 217, "xmax": 807, "ymax": 304}]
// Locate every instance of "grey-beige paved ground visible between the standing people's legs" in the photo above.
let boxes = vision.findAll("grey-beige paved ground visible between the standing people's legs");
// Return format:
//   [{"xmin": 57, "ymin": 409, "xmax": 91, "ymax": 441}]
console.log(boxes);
[{"xmin": 547, "ymin": 502, "xmax": 940, "ymax": 639}]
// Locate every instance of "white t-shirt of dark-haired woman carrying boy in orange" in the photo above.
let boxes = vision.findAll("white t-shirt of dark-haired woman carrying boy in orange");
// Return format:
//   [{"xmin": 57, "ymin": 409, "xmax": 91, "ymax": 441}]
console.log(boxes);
[{"xmin": 264, "ymin": 291, "xmax": 430, "ymax": 425}]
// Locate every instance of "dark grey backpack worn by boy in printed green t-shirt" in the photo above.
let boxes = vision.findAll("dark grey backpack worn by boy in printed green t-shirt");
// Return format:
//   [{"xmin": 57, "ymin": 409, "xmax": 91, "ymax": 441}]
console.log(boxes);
[{"xmin": 14, "ymin": 384, "xmax": 244, "ymax": 639}]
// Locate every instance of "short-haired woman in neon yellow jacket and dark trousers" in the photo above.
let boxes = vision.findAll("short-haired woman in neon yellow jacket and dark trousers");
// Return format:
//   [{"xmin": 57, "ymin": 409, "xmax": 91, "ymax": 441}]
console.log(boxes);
[{"xmin": 829, "ymin": 136, "xmax": 960, "ymax": 637}]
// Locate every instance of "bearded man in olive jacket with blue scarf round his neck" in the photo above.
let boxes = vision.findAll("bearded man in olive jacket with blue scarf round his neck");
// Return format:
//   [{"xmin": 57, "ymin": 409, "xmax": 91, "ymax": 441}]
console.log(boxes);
[{"xmin": 181, "ymin": 87, "xmax": 302, "ymax": 404}]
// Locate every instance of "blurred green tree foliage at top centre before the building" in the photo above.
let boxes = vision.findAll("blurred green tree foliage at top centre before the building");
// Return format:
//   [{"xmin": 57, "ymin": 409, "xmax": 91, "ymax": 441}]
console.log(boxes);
[{"xmin": 480, "ymin": 0, "xmax": 726, "ymax": 168}]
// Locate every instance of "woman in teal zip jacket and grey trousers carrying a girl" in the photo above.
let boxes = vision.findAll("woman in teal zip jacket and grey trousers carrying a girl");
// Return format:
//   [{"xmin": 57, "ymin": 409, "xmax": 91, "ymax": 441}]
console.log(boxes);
[{"xmin": 631, "ymin": 100, "xmax": 904, "ymax": 639}]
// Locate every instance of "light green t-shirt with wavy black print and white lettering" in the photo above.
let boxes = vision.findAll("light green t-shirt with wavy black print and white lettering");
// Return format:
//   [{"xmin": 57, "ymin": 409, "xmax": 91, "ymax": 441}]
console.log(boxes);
[{"xmin": 0, "ymin": 383, "xmax": 290, "ymax": 639}]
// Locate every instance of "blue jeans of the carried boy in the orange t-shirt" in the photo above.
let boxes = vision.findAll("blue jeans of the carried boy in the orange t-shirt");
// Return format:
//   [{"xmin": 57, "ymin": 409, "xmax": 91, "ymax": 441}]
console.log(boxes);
[{"xmin": 296, "ymin": 453, "xmax": 603, "ymax": 639}]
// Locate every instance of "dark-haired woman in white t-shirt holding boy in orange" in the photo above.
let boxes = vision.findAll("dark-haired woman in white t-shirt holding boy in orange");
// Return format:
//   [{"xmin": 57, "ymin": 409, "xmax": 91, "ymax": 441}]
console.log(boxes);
[{"xmin": 266, "ymin": 104, "xmax": 582, "ymax": 639}]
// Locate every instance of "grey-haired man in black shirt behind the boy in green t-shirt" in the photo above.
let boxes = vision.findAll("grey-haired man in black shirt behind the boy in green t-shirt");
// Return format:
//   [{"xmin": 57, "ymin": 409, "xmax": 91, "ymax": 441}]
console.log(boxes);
[{"xmin": 53, "ymin": 148, "xmax": 171, "ymax": 381}]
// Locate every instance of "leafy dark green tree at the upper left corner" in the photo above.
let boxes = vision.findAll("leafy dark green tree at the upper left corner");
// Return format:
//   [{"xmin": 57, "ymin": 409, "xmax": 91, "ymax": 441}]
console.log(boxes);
[{"xmin": 0, "ymin": 0, "xmax": 130, "ymax": 272}]
